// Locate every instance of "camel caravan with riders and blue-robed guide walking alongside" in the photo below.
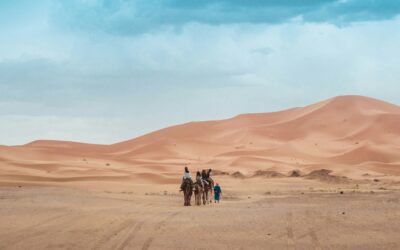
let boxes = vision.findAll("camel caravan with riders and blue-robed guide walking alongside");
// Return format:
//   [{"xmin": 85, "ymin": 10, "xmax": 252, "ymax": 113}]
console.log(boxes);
[{"xmin": 181, "ymin": 167, "xmax": 221, "ymax": 206}]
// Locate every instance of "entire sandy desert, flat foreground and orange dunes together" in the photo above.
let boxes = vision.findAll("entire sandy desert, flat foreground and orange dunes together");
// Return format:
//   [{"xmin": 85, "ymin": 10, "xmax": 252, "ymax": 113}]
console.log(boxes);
[{"xmin": 0, "ymin": 96, "xmax": 400, "ymax": 249}]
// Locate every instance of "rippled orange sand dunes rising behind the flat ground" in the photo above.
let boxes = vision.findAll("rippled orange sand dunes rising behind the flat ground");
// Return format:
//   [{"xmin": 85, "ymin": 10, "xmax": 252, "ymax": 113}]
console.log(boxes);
[{"xmin": 0, "ymin": 96, "xmax": 400, "ymax": 183}]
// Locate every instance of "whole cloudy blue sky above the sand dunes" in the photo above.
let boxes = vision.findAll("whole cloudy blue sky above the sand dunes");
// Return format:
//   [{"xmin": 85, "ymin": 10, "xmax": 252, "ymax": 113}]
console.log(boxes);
[{"xmin": 0, "ymin": 0, "xmax": 400, "ymax": 145}]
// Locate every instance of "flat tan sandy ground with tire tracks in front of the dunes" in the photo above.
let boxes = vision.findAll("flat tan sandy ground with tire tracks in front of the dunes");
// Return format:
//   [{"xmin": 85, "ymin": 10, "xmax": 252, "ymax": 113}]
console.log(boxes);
[{"xmin": 0, "ymin": 176, "xmax": 400, "ymax": 250}]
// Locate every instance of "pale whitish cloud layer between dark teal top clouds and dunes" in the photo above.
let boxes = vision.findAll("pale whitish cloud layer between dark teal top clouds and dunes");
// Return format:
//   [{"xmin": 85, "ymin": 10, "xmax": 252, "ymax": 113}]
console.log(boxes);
[{"xmin": 0, "ymin": 12, "xmax": 400, "ymax": 144}]
